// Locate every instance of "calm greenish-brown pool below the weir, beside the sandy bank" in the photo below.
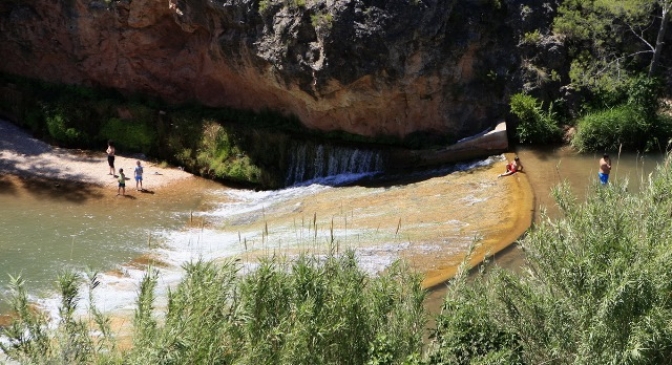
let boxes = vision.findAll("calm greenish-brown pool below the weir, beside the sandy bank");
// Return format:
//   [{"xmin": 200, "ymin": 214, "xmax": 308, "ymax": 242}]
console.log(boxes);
[{"xmin": 0, "ymin": 176, "xmax": 218, "ymax": 311}]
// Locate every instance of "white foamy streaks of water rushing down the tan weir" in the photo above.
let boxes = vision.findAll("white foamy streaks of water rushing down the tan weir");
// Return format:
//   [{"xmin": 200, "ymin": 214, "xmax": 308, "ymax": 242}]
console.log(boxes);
[{"xmin": 3, "ymin": 156, "xmax": 503, "ymax": 336}]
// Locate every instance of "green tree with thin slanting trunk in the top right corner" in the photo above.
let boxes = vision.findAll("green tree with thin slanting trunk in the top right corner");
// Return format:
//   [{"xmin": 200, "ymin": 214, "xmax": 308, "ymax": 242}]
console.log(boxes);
[{"xmin": 553, "ymin": 0, "xmax": 672, "ymax": 86}]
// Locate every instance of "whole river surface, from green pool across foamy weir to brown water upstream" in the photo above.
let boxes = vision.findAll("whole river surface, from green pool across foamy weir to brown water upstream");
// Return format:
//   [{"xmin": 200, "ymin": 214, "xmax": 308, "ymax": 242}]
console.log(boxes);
[{"xmin": 0, "ymin": 144, "xmax": 662, "ymax": 322}]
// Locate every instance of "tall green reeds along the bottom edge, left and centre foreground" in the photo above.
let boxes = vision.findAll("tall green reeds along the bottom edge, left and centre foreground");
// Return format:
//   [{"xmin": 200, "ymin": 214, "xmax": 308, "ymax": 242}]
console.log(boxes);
[{"xmin": 3, "ymin": 252, "xmax": 425, "ymax": 364}]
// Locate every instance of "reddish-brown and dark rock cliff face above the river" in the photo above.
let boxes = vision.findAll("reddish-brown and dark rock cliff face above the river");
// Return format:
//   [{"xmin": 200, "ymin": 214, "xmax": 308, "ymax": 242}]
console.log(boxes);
[{"xmin": 0, "ymin": 0, "xmax": 534, "ymax": 139}]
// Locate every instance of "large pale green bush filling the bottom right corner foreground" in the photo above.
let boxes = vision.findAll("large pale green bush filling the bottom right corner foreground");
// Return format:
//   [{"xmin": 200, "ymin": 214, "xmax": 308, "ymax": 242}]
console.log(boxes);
[{"xmin": 428, "ymin": 161, "xmax": 672, "ymax": 364}]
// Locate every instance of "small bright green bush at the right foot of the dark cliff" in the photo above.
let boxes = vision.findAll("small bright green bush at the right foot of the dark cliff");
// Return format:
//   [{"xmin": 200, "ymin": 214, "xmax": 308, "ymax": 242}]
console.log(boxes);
[{"xmin": 511, "ymin": 93, "xmax": 561, "ymax": 143}]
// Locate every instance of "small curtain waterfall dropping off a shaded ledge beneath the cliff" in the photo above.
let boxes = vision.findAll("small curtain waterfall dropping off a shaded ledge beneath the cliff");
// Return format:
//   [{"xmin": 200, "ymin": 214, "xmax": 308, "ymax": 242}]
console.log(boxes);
[{"xmin": 285, "ymin": 142, "xmax": 384, "ymax": 186}]
